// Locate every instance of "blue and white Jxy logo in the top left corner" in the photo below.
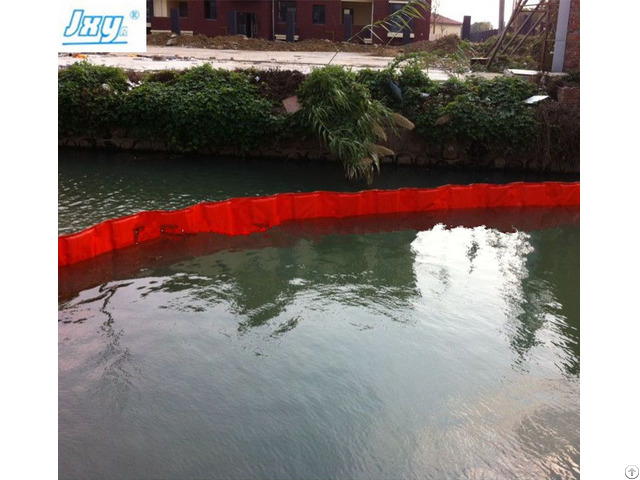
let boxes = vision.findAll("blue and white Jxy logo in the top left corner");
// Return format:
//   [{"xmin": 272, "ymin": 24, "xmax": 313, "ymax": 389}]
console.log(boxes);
[{"xmin": 63, "ymin": 10, "xmax": 127, "ymax": 45}]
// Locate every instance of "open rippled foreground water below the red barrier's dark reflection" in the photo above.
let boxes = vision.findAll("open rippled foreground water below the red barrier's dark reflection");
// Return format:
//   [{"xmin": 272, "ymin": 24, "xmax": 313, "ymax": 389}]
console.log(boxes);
[{"xmin": 59, "ymin": 225, "xmax": 579, "ymax": 479}]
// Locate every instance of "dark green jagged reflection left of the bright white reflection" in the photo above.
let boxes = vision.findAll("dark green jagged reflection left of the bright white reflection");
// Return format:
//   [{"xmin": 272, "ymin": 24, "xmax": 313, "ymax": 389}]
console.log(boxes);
[{"xmin": 136, "ymin": 232, "xmax": 418, "ymax": 336}]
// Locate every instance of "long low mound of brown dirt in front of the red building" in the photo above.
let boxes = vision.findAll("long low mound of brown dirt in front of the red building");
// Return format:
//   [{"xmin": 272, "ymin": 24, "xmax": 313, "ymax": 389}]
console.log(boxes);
[{"xmin": 147, "ymin": 33, "xmax": 402, "ymax": 56}]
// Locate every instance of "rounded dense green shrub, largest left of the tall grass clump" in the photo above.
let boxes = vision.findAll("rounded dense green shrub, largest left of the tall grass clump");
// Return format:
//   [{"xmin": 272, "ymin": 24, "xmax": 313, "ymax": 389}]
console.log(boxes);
[{"xmin": 121, "ymin": 64, "xmax": 278, "ymax": 151}]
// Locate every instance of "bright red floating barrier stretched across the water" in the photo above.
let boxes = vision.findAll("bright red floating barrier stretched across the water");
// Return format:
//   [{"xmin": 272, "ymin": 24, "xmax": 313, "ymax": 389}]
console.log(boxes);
[{"xmin": 58, "ymin": 182, "xmax": 580, "ymax": 267}]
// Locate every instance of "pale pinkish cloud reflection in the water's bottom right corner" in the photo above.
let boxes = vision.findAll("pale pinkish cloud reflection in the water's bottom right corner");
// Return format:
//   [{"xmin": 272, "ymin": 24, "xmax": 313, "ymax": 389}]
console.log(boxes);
[{"xmin": 411, "ymin": 376, "xmax": 580, "ymax": 480}]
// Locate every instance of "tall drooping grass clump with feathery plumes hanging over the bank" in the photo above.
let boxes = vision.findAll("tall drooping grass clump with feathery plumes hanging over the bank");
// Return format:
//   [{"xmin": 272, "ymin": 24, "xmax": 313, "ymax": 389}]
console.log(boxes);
[{"xmin": 297, "ymin": 66, "xmax": 413, "ymax": 184}]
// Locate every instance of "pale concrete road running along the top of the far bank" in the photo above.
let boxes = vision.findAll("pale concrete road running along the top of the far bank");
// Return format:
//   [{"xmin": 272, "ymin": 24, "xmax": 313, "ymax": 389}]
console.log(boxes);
[{"xmin": 58, "ymin": 46, "xmax": 449, "ymax": 80}]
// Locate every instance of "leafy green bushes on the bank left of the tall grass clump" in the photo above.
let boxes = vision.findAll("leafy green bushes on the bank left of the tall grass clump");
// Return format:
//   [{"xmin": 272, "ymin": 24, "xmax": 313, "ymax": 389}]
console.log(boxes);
[{"xmin": 58, "ymin": 63, "xmax": 279, "ymax": 152}]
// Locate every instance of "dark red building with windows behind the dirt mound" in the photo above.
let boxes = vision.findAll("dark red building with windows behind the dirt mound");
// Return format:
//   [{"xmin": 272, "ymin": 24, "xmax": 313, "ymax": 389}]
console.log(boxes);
[{"xmin": 147, "ymin": 0, "xmax": 430, "ymax": 44}]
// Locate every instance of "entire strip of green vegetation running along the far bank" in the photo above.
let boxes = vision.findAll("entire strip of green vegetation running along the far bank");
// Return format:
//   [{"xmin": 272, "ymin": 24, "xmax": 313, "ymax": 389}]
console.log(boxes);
[{"xmin": 58, "ymin": 57, "xmax": 579, "ymax": 182}]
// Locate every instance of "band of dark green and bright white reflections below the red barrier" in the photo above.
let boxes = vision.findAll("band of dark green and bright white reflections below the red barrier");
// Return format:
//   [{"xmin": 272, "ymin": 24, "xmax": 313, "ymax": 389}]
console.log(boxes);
[{"xmin": 72, "ymin": 218, "xmax": 579, "ymax": 375}]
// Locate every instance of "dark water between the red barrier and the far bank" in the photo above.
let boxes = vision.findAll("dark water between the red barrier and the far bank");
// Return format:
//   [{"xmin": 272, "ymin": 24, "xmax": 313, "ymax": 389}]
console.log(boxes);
[{"xmin": 58, "ymin": 149, "xmax": 578, "ymax": 235}]
